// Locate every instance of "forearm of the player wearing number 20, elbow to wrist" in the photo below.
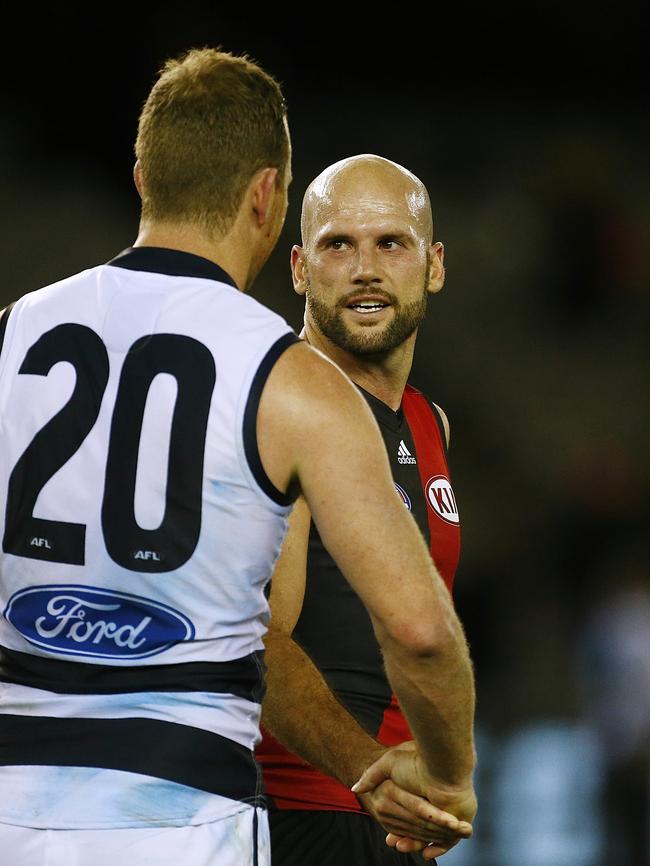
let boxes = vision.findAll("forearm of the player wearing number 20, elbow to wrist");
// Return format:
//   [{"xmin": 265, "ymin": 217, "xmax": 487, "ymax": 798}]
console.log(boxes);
[{"xmin": 374, "ymin": 611, "xmax": 475, "ymax": 786}]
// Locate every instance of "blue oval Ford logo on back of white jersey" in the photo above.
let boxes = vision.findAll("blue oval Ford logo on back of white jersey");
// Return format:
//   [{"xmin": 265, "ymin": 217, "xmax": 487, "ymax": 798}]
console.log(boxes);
[{"xmin": 4, "ymin": 586, "xmax": 195, "ymax": 659}]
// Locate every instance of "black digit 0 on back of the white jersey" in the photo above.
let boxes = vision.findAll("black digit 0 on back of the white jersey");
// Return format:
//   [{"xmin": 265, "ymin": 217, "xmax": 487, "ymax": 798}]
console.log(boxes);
[{"xmin": 102, "ymin": 334, "xmax": 217, "ymax": 573}]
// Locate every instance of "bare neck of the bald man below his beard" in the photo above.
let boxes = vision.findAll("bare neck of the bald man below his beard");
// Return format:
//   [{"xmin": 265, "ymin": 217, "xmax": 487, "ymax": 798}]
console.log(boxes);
[{"xmin": 301, "ymin": 317, "xmax": 417, "ymax": 412}]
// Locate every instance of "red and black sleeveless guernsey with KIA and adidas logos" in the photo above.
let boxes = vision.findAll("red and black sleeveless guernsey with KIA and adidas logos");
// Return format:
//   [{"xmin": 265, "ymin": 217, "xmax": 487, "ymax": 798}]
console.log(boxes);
[{"xmin": 256, "ymin": 385, "xmax": 460, "ymax": 812}]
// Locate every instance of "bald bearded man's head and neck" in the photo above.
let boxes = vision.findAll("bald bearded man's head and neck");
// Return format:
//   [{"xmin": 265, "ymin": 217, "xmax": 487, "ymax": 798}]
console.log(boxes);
[{"xmin": 291, "ymin": 155, "xmax": 445, "ymax": 409}]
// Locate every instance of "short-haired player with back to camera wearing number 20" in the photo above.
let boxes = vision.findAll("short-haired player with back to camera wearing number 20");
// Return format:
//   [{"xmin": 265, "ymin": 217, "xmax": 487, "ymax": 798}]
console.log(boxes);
[{"xmin": 0, "ymin": 49, "xmax": 473, "ymax": 866}]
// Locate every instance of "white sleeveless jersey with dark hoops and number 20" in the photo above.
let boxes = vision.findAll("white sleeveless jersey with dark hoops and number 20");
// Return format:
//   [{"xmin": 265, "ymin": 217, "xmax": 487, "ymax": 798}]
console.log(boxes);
[{"xmin": 0, "ymin": 247, "xmax": 298, "ymax": 829}]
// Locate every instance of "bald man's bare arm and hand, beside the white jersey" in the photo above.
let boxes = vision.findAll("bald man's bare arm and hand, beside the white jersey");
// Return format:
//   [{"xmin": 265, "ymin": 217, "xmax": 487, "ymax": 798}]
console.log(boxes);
[{"xmin": 262, "ymin": 497, "xmax": 471, "ymax": 850}]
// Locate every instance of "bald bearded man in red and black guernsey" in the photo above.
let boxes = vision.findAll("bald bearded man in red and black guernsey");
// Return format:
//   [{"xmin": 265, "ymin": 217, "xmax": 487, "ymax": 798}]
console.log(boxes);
[{"xmin": 257, "ymin": 155, "xmax": 476, "ymax": 866}]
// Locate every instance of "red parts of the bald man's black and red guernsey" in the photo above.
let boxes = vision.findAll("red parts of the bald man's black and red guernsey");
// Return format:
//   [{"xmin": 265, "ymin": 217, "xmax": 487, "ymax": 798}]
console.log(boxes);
[{"xmin": 256, "ymin": 385, "xmax": 460, "ymax": 812}]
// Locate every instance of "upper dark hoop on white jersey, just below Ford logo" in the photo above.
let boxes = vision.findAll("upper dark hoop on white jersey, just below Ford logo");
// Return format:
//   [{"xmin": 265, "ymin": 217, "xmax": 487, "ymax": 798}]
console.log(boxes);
[{"xmin": 0, "ymin": 646, "xmax": 264, "ymax": 704}]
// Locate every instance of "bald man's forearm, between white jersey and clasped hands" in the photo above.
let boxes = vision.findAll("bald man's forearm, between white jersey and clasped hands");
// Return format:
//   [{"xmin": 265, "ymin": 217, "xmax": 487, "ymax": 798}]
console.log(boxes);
[{"xmin": 262, "ymin": 629, "xmax": 384, "ymax": 787}]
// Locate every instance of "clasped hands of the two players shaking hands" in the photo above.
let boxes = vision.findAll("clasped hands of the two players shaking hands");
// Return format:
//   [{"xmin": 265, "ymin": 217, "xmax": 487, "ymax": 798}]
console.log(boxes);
[{"xmin": 352, "ymin": 742, "xmax": 477, "ymax": 860}]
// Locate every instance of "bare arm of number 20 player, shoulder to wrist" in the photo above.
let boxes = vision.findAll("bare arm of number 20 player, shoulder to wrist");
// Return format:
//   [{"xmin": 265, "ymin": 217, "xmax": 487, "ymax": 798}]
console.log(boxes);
[{"xmin": 258, "ymin": 345, "xmax": 474, "ymax": 786}]
